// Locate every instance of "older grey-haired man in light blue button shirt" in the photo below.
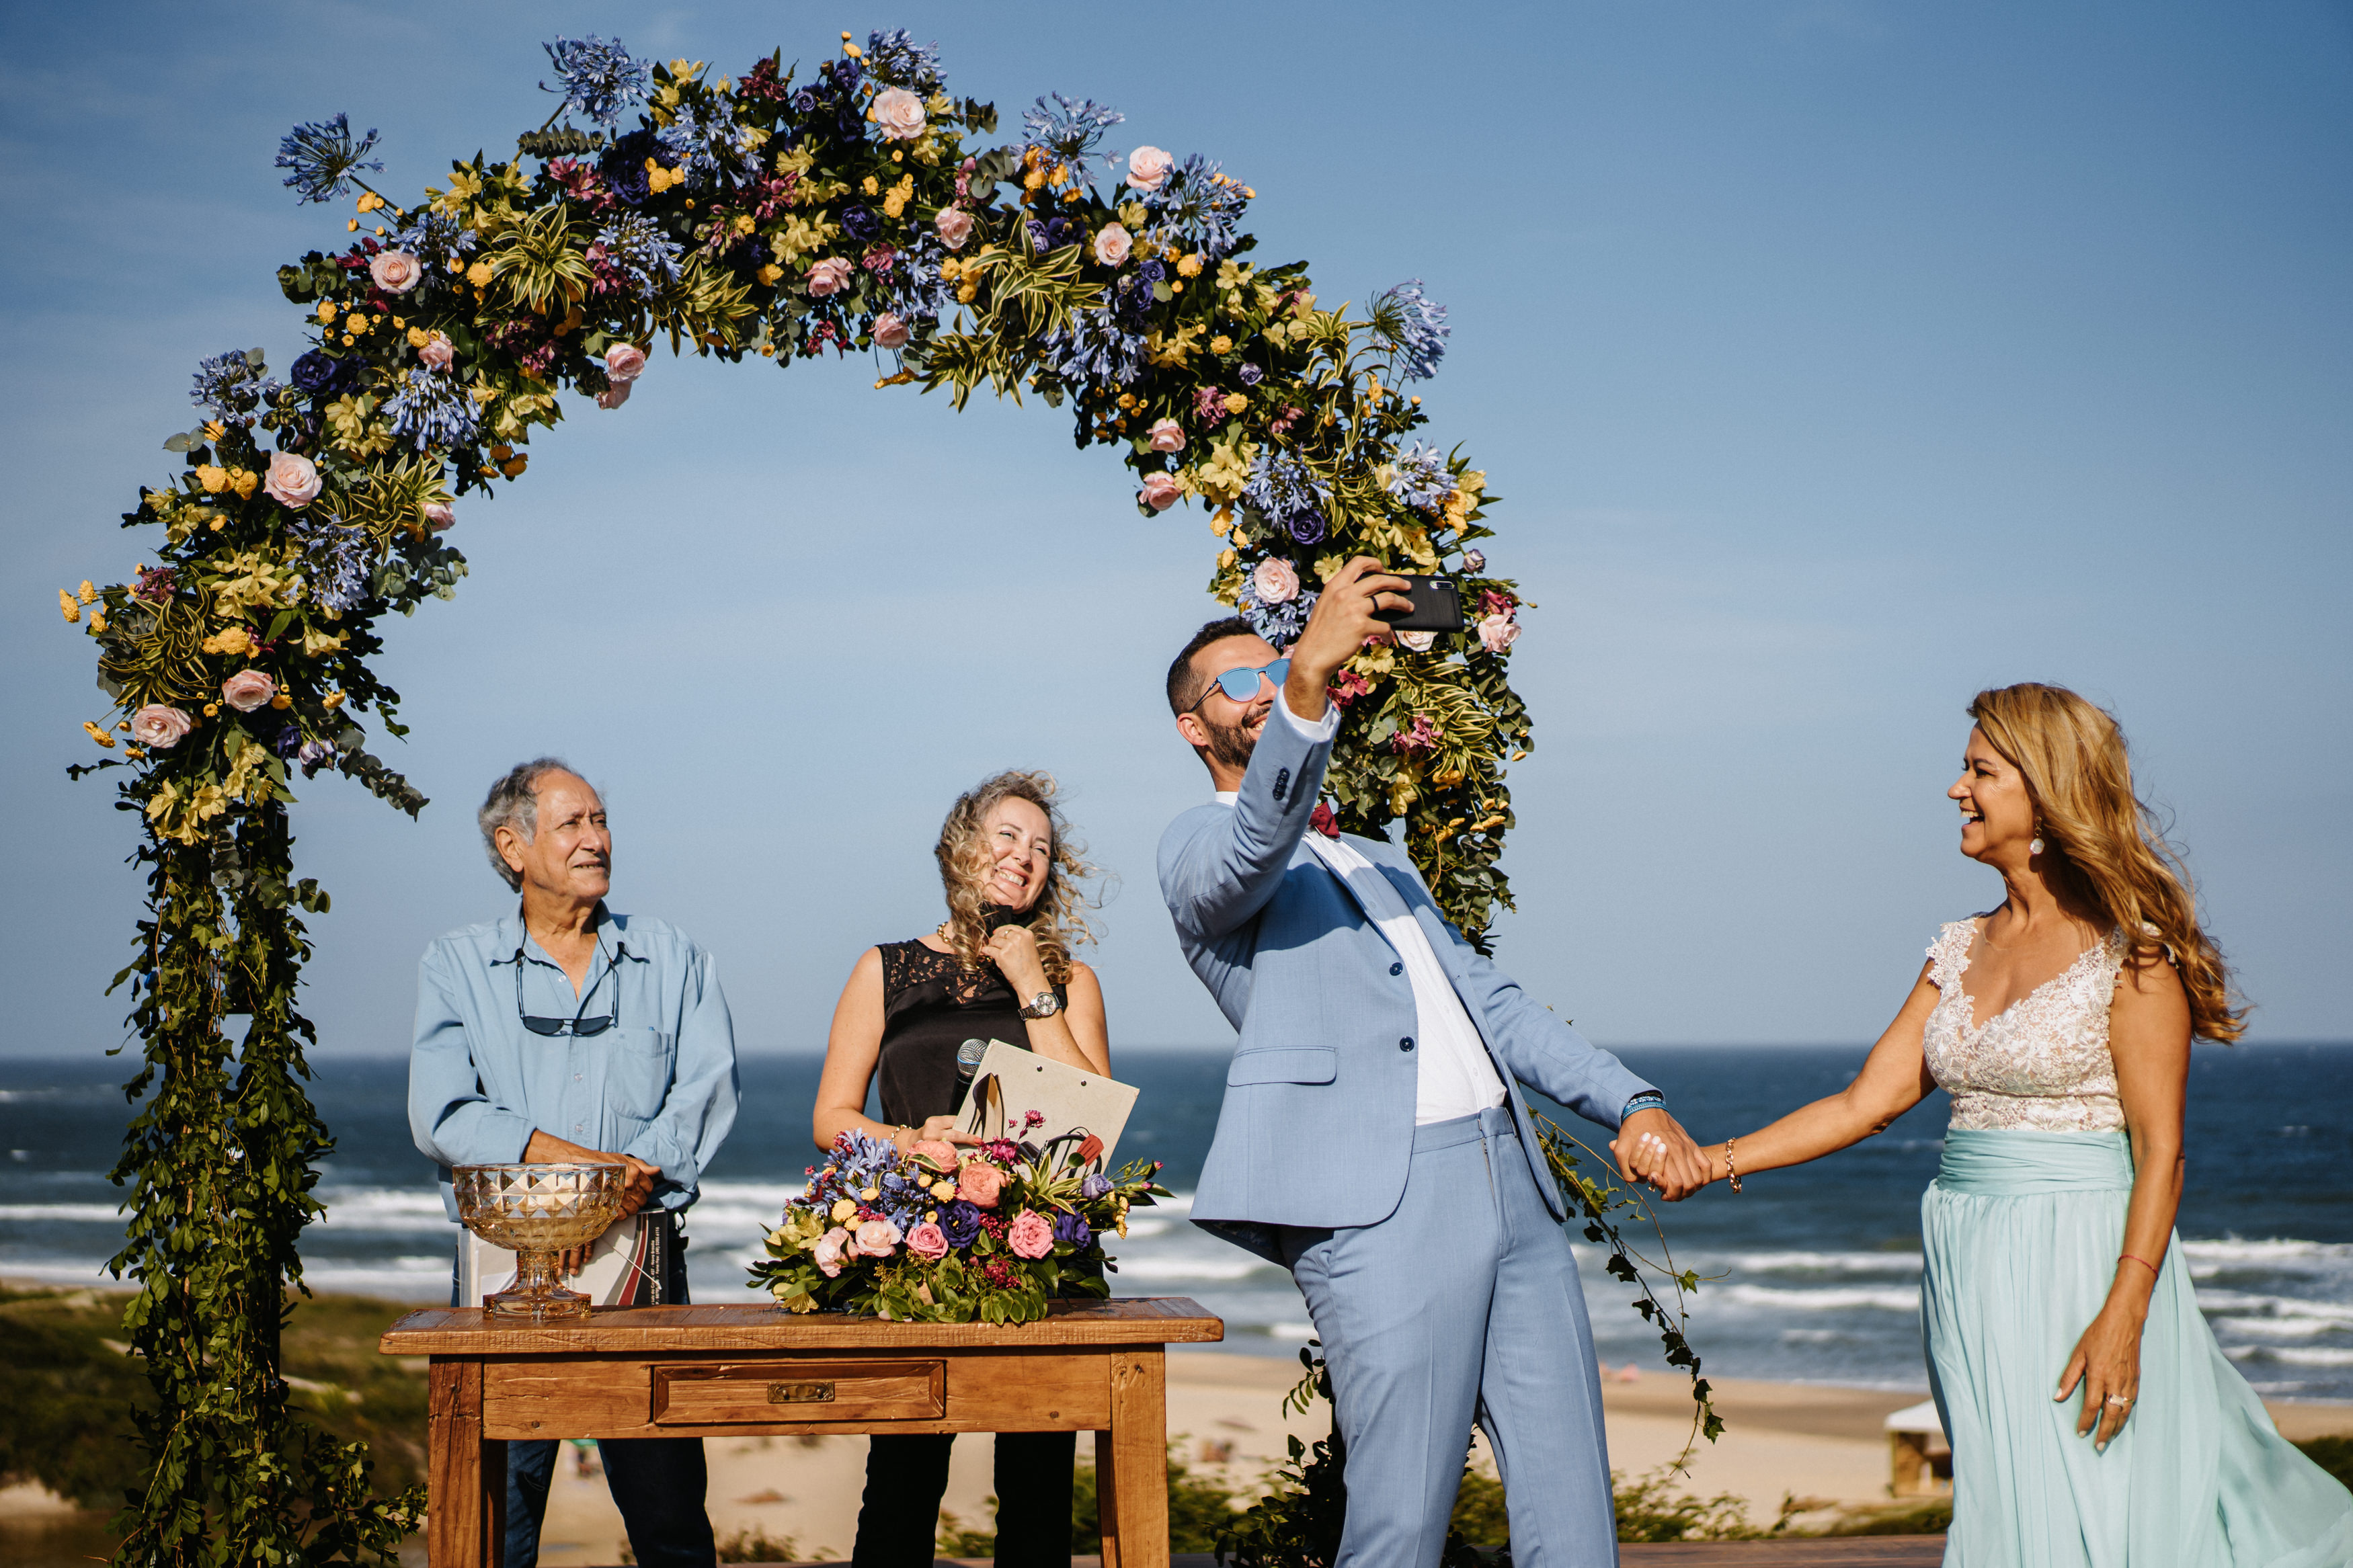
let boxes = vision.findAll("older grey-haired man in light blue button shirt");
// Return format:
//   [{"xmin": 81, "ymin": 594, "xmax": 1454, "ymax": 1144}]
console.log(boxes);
[{"xmin": 409, "ymin": 757, "xmax": 737, "ymax": 1568}]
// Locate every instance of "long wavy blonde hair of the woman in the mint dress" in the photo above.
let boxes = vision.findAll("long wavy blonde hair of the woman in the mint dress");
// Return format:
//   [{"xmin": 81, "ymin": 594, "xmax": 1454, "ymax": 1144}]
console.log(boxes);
[{"xmin": 1970, "ymin": 682, "xmax": 2245, "ymax": 1042}]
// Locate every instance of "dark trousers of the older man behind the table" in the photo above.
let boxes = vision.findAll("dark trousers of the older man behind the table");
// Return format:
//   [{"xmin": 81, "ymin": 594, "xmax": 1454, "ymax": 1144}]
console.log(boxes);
[{"xmin": 452, "ymin": 1223, "xmax": 718, "ymax": 1568}]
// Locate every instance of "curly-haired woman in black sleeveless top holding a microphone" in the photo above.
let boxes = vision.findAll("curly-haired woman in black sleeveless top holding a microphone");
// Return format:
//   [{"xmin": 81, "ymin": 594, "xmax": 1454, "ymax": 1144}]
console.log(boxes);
[{"xmin": 812, "ymin": 771, "xmax": 1111, "ymax": 1568}]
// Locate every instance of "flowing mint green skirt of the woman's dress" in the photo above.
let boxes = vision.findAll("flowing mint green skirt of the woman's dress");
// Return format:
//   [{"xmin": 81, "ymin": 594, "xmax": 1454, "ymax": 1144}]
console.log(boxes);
[{"xmin": 1920, "ymin": 1130, "xmax": 2353, "ymax": 1568}]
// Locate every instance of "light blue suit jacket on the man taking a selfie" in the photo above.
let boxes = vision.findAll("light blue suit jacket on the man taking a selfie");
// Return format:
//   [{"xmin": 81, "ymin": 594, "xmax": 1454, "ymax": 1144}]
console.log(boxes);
[{"xmin": 1160, "ymin": 698, "xmax": 1650, "ymax": 1262}]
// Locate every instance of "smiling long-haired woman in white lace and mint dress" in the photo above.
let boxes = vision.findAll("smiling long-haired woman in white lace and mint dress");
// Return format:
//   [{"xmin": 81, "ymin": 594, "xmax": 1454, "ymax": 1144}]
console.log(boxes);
[{"xmin": 1706, "ymin": 686, "xmax": 2353, "ymax": 1568}]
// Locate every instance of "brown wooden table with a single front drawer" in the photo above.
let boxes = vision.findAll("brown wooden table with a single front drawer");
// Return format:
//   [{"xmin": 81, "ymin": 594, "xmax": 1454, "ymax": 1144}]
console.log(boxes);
[{"xmin": 376, "ymin": 1295, "xmax": 1226, "ymax": 1568}]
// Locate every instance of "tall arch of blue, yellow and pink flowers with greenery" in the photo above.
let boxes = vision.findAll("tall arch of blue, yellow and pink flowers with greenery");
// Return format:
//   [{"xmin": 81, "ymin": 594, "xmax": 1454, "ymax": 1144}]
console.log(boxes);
[{"xmin": 59, "ymin": 30, "xmax": 1529, "ymax": 1563}]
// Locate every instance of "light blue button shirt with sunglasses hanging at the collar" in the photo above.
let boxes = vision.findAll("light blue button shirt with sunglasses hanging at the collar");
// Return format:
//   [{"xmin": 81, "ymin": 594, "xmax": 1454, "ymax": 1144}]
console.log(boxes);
[{"xmin": 409, "ymin": 907, "xmax": 737, "ymax": 1220}]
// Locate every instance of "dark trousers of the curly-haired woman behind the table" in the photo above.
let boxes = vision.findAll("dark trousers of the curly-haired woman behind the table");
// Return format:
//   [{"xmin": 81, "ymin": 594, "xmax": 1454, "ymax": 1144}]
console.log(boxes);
[{"xmin": 850, "ymin": 1432, "xmax": 1078, "ymax": 1568}]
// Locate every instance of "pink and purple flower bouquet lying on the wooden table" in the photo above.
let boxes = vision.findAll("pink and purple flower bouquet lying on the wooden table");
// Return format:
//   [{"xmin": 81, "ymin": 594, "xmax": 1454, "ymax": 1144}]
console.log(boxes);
[{"xmin": 751, "ymin": 1112, "xmax": 1167, "ymax": 1323}]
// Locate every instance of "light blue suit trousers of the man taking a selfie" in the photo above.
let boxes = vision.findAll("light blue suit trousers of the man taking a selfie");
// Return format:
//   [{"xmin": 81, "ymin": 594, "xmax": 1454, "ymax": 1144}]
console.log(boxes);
[{"xmin": 1283, "ymin": 1107, "xmax": 1619, "ymax": 1568}]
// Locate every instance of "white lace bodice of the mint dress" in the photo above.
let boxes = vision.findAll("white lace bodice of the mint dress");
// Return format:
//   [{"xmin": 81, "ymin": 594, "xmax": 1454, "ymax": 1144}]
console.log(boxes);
[{"xmin": 1920, "ymin": 919, "xmax": 2125, "ymax": 1133}]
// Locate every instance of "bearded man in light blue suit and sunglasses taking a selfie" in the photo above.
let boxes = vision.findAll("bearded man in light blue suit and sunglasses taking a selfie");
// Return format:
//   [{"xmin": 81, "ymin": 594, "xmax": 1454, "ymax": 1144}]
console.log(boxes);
[{"xmin": 1160, "ymin": 557, "xmax": 1706, "ymax": 1568}]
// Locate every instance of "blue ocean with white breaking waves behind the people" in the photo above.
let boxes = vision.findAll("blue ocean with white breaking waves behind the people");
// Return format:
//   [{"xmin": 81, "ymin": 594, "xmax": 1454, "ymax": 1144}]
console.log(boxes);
[{"xmin": 0, "ymin": 1044, "xmax": 2353, "ymax": 1399}]
